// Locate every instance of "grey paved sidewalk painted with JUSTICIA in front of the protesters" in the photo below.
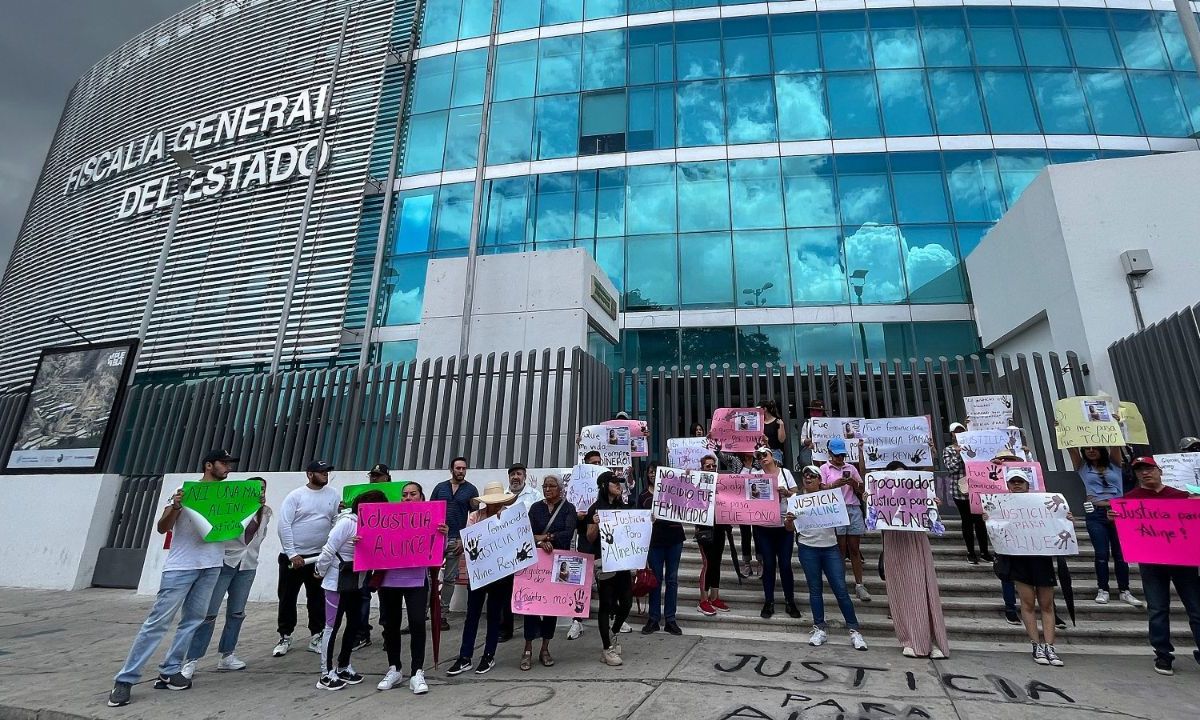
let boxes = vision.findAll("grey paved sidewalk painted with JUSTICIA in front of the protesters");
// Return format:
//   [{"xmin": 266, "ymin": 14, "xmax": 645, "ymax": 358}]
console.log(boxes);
[{"xmin": 0, "ymin": 589, "xmax": 1200, "ymax": 720}]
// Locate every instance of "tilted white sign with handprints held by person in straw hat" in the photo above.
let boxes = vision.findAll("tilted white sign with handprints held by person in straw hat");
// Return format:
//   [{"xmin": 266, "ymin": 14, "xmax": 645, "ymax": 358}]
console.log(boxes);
[{"xmin": 461, "ymin": 504, "xmax": 538, "ymax": 590}]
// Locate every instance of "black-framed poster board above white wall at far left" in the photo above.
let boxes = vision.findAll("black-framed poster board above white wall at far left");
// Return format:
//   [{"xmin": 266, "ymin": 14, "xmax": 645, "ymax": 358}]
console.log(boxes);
[{"xmin": 5, "ymin": 340, "xmax": 137, "ymax": 473}]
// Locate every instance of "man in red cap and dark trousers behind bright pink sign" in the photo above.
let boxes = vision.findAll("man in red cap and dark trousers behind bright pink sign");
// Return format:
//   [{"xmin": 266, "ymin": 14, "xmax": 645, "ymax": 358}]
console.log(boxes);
[{"xmin": 1110, "ymin": 456, "xmax": 1200, "ymax": 676}]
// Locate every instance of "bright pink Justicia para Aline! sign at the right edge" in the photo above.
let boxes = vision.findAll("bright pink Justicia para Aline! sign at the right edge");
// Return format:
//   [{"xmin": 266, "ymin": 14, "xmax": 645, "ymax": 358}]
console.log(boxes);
[{"xmin": 1112, "ymin": 498, "xmax": 1200, "ymax": 566}]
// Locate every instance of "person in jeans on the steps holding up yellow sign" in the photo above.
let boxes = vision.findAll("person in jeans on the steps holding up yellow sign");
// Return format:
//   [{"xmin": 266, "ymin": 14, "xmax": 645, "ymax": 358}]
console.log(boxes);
[{"xmin": 1070, "ymin": 446, "xmax": 1145, "ymax": 607}]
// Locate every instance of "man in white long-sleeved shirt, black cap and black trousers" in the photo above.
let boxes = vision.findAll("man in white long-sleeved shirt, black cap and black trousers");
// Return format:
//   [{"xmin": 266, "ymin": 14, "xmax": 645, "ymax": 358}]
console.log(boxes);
[{"xmin": 271, "ymin": 460, "xmax": 342, "ymax": 658}]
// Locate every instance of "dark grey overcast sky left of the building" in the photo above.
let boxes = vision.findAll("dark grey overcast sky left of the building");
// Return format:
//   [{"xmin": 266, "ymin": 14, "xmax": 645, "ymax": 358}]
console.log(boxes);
[{"xmin": 0, "ymin": 0, "xmax": 196, "ymax": 266}]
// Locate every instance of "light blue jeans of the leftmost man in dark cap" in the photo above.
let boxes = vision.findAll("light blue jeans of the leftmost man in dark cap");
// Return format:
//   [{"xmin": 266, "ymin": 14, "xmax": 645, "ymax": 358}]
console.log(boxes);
[{"xmin": 114, "ymin": 568, "xmax": 221, "ymax": 683}]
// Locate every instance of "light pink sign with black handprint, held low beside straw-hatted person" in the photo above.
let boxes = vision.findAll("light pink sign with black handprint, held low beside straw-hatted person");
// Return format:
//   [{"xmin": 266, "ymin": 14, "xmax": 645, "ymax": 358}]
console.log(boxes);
[{"xmin": 512, "ymin": 550, "xmax": 592, "ymax": 618}]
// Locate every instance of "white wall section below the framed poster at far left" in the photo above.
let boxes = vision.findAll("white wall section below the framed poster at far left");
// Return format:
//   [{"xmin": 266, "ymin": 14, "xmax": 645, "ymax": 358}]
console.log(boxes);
[{"xmin": 0, "ymin": 474, "xmax": 121, "ymax": 590}]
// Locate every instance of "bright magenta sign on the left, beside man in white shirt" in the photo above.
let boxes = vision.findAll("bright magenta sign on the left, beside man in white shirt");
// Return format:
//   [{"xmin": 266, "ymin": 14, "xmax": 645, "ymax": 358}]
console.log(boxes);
[{"xmin": 354, "ymin": 503, "xmax": 446, "ymax": 572}]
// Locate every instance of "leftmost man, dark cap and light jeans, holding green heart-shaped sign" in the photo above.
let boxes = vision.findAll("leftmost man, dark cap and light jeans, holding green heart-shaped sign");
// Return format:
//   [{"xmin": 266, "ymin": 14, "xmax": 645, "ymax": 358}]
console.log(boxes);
[{"xmin": 108, "ymin": 450, "xmax": 238, "ymax": 708}]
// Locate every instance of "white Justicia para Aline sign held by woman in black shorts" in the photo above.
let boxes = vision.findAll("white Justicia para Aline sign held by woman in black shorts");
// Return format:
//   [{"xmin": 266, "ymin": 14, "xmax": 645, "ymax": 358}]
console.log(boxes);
[{"xmin": 982, "ymin": 492, "xmax": 1079, "ymax": 556}]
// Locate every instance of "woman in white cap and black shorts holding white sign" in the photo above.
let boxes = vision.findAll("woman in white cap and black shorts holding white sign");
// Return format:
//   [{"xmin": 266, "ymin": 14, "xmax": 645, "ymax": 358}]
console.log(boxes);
[{"xmin": 983, "ymin": 469, "xmax": 1075, "ymax": 667}]
